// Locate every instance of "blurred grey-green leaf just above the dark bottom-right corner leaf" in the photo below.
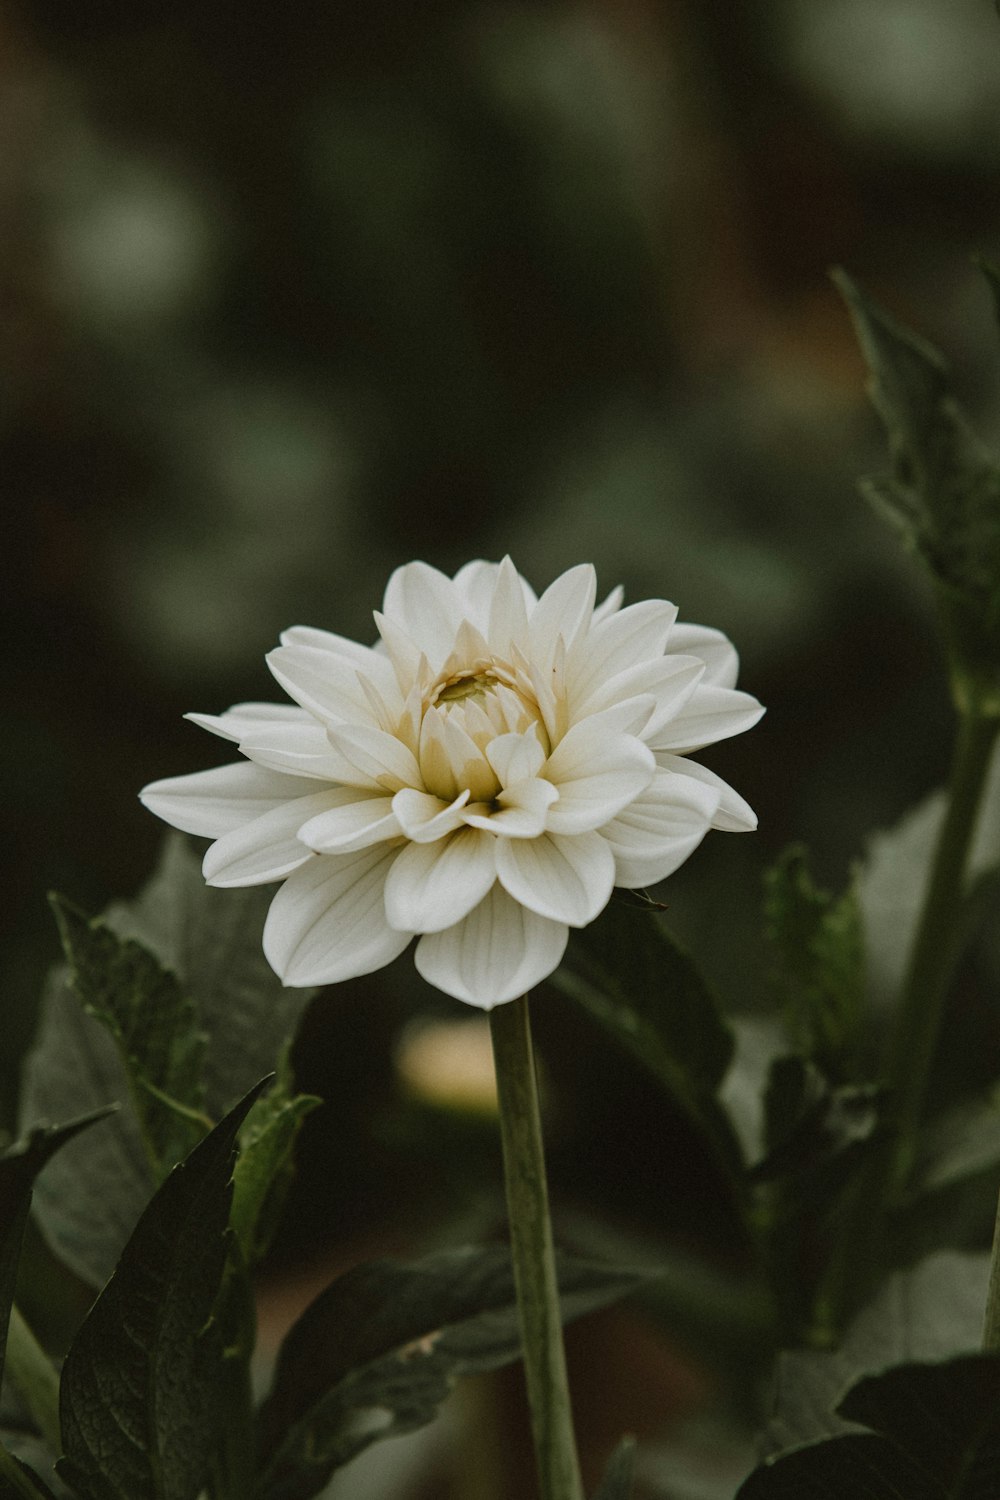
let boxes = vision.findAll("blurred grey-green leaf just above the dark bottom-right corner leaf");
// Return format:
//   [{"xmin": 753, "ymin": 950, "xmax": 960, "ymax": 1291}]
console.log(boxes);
[{"xmin": 766, "ymin": 1251, "xmax": 990, "ymax": 1452}]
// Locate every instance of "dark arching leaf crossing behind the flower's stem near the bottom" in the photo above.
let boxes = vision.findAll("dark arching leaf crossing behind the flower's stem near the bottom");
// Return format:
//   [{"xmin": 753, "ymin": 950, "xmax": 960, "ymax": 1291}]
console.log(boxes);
[{"xmin": 258, "ymin": 1247, "xmax": 652, "ymax": 1500}]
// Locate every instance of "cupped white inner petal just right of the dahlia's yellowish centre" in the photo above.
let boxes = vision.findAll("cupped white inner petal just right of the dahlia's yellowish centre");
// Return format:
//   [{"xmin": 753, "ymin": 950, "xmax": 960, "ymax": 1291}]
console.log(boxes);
[{"xmin": 544, "ymin": 710, "xmax": 655, "ymax": 834}]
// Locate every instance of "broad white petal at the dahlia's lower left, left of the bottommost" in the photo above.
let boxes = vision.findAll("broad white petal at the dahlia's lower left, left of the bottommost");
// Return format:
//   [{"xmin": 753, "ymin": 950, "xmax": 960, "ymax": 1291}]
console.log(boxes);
[{"xmin": 264, "ymin": 845, "xmax": 412, "ymax": 987}]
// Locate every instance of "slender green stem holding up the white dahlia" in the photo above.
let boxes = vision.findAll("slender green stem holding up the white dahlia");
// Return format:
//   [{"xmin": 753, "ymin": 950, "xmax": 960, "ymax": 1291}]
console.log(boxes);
[{"xmin": 490, "ymin": 996, "xmax": 583, "ymax": 1500}]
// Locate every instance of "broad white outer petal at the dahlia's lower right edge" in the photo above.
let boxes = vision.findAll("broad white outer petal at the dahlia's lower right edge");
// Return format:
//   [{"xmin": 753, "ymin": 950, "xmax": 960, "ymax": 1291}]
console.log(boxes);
[{"xmin": 601, "ymin": 770, "xmax": 720, "ymax": 890}]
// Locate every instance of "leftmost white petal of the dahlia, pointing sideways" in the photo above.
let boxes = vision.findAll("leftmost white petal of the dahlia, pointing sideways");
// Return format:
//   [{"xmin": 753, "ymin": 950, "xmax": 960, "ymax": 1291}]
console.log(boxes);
[{"xmin": 139, "ymin": 761, "xmax": 313, "ymax": 839}]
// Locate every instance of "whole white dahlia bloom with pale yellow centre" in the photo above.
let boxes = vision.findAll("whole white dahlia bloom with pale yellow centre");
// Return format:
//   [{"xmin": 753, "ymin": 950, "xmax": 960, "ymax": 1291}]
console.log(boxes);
[{"xmin": 141, "ymin": 558, "xmax": 763, "ymax": 1008}]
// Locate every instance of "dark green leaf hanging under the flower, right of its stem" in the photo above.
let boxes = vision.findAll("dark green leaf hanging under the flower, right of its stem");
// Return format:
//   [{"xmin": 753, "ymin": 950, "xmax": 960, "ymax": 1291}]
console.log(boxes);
[{"xmin": 550, "ymin": 897, "xmax": 741, "ymax": 1172}]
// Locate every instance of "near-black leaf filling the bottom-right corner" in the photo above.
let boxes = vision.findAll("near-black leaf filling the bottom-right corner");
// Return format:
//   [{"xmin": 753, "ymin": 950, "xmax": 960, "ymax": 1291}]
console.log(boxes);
[{"xmin": 738, "ymin": 1355, "xmax": 1000, "ymax": 1500}]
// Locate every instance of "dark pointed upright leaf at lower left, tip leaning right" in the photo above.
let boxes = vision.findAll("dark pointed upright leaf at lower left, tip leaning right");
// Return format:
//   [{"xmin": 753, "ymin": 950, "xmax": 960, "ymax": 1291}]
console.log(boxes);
[{"xmin": 58, "ymin": 1080, "xmax": 267, "ymax": 1500}]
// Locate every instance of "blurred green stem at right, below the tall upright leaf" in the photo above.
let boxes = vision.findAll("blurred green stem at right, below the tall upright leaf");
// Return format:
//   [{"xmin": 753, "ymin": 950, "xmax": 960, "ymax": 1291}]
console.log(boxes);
[{"xmin": 886, "ymin": 711, "xmax": 1000, "ymax": 1197}]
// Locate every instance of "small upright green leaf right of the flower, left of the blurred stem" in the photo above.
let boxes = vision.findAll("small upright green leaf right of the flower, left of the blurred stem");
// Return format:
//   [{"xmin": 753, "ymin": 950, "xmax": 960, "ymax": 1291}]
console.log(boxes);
[{"xmin": 765, "ymin": 845, "xmax": 865, "ymax": 1077}]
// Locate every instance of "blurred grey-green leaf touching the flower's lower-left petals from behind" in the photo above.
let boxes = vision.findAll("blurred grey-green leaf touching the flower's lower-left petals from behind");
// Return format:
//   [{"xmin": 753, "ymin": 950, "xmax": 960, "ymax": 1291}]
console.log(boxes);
[{"xmin": 106, "ymin": 833, "xmax": 316, "ymax": 1119}]
